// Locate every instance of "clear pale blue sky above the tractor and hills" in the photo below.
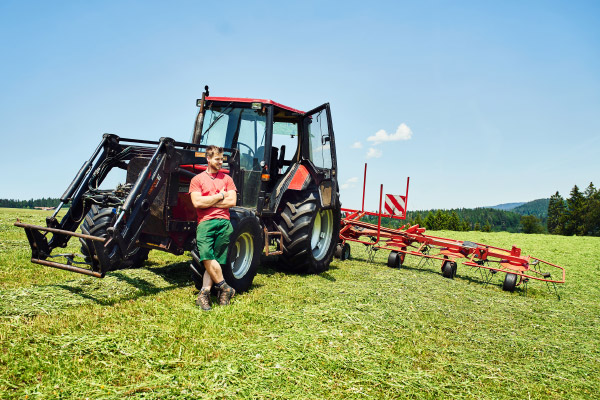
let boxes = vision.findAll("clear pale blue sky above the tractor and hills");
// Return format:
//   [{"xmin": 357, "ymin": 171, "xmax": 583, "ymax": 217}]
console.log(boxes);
[{"xmin": 0, "ymin": 0, "xmax": 600, "ymax": 210}]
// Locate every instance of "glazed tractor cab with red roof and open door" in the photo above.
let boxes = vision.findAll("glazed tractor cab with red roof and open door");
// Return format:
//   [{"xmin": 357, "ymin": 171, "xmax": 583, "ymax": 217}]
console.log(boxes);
[{"xmin": 192, "ymin": 96, "xmax": 336, "ymax": 214}]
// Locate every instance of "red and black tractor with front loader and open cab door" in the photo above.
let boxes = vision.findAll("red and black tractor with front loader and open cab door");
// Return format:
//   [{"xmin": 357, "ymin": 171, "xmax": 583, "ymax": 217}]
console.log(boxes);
[{"xmin": 15, "ymin": 86, "xmax": 341, "ymax": 292}]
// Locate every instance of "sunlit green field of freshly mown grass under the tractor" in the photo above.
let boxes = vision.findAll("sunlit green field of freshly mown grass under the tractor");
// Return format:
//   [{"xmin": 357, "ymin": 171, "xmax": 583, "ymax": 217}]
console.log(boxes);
[{"xmin": 0, "ymin": 209, "xmax": 600, "ymax": 399}]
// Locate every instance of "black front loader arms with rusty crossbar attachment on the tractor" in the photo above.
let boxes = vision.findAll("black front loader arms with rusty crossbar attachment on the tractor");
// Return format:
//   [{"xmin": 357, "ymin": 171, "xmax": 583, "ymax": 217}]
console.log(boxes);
[{"xmin": 15, "ymin": 134, "xmax": 181, "ymax": 277}]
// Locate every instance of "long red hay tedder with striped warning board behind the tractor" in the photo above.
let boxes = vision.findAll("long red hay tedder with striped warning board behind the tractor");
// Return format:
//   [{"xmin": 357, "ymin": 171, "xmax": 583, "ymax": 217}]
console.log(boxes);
[{"xmin": 335, "ymin": 165, "xmax": 565, "ymax": 295}]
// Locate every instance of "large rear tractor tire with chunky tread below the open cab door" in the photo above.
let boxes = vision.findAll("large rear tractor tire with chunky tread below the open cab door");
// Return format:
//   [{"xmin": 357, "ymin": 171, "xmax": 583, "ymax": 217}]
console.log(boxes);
[{"xmin": 277, "ymin": 191, "xmax": 340, "ymax": 274}]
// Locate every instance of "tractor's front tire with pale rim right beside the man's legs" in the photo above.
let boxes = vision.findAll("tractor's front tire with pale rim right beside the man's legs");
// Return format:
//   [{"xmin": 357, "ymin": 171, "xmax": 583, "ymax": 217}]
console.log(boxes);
[{"xmin": 221, "ymin": 212, "xmax": 264, "ymax": 293}]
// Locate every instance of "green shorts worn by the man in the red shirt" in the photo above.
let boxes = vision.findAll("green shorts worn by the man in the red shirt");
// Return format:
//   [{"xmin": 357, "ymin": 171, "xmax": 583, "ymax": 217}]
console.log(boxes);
[{"xmin": 196, "ymin": 218, "xmax": 233, "ymax": 264}]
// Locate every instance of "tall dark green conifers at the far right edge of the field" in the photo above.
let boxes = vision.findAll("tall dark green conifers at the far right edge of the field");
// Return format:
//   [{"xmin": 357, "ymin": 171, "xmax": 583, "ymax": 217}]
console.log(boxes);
[{"xmin": 548, "ymin": 182, "xmax": 600, "ymax": 236}]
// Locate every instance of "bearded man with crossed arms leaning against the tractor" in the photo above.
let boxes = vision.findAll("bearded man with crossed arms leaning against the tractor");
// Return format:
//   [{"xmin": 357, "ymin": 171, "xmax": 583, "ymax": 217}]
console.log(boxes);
[{"xmin": 190, "ymin": 146, "xmax": 237, "ymax": 311}]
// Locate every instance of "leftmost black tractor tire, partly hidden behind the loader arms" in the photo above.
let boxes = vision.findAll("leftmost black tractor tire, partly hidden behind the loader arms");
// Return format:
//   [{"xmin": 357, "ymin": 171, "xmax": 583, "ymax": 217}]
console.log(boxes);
[{"xmin": 79, "ymin": 205, "xmax": 150, "ymax": 273}]
